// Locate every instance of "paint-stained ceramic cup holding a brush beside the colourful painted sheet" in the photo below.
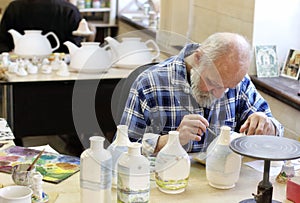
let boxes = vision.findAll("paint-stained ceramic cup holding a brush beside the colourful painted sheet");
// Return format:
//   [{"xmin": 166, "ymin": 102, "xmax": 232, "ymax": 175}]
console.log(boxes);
[{"xmin": 12, "ymin": 164, "xmax": 36, "ymax": 186}]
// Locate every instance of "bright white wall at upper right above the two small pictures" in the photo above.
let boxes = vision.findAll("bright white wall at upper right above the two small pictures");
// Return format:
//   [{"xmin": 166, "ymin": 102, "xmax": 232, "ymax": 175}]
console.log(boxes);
[{"xmin": 252, "ymin": 0, "xmax": 300, "ymax": 72}]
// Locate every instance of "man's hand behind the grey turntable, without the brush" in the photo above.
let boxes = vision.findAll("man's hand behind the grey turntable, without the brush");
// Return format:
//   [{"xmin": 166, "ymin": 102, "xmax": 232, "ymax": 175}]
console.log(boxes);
[{"xmin": 240, "ymin": 112, "xmax": 276, "ymax": 135}]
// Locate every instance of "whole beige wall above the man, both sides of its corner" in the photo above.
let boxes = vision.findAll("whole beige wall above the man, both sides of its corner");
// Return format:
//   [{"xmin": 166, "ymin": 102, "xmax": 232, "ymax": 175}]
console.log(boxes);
[{"xmin": 160, "ymin": 0, "xmax": 255, "ymax": 49}]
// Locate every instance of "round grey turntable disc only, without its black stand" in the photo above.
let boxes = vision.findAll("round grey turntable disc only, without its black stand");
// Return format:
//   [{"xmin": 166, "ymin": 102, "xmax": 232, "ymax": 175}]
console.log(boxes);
[{"xmin": 230, "ymin": 135, "xmax": 300, "ymax": 161}]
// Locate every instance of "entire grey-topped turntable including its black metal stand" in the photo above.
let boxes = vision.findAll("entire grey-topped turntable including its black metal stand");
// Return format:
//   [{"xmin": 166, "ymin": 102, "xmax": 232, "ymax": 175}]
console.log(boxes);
[{"xmin": 230, "ymin": 135, "xmax": 300, "ymax": 203}]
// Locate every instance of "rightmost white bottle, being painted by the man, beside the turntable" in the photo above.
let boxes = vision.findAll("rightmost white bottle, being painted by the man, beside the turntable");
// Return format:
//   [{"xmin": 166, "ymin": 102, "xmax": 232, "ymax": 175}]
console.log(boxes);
[{"xmin": 206, "ymin": 126, "xmax": 242, "ymax": 189}]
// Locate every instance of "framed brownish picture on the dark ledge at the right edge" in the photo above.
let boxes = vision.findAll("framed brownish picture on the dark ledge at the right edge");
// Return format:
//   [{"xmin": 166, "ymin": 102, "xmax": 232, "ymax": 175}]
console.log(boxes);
[{"xmin": 281, "ymin": 49, "xmax": 300, "ymax": 80}]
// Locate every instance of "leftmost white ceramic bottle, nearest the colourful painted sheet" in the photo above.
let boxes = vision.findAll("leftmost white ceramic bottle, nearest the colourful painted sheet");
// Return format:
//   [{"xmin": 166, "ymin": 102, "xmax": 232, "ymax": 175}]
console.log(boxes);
[{"xmin": 80, "ymin": 136, "xmax": 112, "ymax": 203}]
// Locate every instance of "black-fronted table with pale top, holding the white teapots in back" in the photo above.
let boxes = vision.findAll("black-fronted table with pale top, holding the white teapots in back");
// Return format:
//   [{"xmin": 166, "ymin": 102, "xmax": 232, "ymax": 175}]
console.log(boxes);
[{"xmin": 0, "ymin": 68, "xmax": 134, "ymax": 145}]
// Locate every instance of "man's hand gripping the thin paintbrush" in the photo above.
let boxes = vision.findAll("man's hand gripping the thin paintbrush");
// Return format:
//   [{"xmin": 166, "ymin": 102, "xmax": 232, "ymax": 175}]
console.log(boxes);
[{"xmin": 177, "ymin": 114, "xmax": 209, "ymax": 145}]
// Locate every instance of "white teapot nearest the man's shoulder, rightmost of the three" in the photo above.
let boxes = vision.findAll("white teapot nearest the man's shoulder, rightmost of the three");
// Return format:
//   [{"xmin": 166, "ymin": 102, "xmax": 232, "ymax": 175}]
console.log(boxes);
[{"xmin": 105, "ymin": 36, "xmax": 160, "ymax": 67}]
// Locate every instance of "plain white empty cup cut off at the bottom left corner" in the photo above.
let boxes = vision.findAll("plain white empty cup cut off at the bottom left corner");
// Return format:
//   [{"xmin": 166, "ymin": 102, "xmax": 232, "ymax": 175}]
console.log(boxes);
[{"xmin": 0, "ymin": 185, "xmax": 32, "ymax": 203}]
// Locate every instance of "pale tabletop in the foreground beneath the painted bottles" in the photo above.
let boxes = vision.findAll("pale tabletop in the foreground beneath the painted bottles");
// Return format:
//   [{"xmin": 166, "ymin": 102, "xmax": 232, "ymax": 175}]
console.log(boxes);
[{"xmin": 0, "ymin": 158, "xmax": 291, "ymax": 203}]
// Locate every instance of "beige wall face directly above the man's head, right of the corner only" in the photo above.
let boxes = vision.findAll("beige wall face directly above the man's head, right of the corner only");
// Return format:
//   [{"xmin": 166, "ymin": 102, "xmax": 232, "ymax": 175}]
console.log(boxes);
[{"xmin": 191, "ymin": 0, "xmax": 254, "ymax": 42}]
